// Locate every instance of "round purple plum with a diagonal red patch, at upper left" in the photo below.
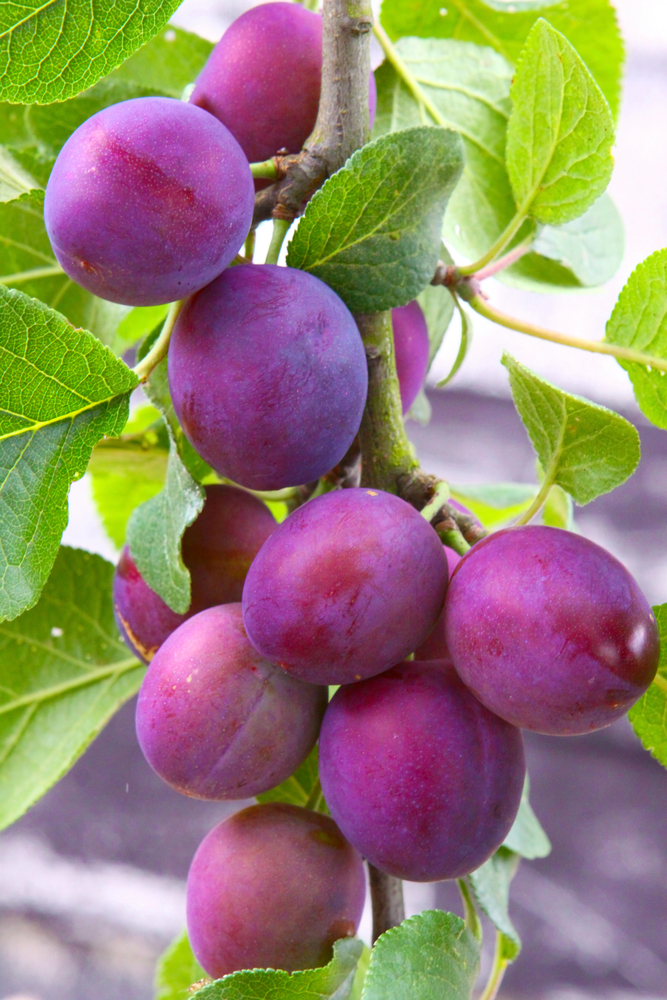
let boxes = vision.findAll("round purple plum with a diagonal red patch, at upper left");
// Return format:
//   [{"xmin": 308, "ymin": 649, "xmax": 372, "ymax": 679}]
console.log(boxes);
[{"xmin": 44, "ymin": 97, "xmax": 254, "ymax": 306}]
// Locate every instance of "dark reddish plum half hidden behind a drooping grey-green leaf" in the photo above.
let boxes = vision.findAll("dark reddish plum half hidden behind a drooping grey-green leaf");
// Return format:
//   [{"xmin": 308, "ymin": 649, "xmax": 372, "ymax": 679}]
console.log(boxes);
[{"xmin": 113, "ymin": 485, "xmax": 276, "ymax": 663}]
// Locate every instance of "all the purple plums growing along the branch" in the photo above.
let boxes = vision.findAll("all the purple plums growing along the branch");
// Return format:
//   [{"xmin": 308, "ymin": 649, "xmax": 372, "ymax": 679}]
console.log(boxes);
[{"xmin": 45, "ymin": 3, "xmax": 658, "ymax": 977}]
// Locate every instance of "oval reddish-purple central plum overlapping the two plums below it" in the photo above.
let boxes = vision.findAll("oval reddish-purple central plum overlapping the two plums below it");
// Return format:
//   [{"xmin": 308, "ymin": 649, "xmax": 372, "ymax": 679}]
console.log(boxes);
[{"xmin": 243, "ymin": 489, "xmax": 447, "ymax": 684}]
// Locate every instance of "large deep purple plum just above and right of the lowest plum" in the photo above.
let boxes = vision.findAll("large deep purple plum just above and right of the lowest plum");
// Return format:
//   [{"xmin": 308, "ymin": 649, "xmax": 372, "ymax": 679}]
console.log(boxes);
[{"xmin": 319, "ymin": 661, "xmax": 525, "ymax": 882}]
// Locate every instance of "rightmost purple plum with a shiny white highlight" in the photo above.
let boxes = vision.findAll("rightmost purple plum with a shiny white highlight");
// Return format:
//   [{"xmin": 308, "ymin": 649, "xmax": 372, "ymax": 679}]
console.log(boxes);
[{"xmin": 444, "ymin": 525, "xmax": 659, "ymax": 736}]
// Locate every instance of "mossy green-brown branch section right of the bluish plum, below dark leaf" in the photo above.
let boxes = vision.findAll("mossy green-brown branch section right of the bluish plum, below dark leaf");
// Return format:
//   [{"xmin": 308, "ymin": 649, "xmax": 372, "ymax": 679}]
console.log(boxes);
[{"xmin": 355, "ymin": 312, "xmax": 419, "ymax": 493}]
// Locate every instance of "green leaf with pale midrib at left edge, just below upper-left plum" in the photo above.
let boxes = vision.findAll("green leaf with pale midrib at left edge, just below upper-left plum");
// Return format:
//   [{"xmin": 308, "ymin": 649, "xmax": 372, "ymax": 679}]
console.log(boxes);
[{"xmin": 0, "ymin": 191, "xmax": 128, "ymax": 346}]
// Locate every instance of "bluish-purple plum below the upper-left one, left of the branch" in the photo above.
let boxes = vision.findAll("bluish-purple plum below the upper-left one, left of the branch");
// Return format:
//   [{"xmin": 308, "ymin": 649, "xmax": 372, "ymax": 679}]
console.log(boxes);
[{"xmin": 169, "ymin": 264, "xmax": 368, "ymax": 490}]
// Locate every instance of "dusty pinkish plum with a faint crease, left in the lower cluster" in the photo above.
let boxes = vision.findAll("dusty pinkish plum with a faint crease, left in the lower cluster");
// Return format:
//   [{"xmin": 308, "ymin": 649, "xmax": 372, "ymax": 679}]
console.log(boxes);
[{"xmin": 136, "ymin": 604, "xmax": 327, "ymax": 800}]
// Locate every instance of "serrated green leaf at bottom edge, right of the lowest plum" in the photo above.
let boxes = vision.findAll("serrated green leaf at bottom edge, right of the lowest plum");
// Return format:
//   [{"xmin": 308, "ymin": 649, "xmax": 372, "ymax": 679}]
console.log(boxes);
[{"xmin": 362, "ymin": 910, "xmax": 479, "ymax": 1000}]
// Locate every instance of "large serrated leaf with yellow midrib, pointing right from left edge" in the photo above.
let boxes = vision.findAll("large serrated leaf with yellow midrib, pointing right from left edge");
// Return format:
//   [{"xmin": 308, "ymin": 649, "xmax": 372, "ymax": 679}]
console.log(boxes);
[{"xmin": 0, "ymin": 286, "xmax": 137, "ymax": 621}]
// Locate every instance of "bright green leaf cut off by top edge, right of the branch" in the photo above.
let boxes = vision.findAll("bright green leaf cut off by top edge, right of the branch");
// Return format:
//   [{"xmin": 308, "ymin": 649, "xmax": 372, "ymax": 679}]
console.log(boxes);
[{"xmin": 382, "ymin": 0, "xmax": 624, "ymax": 122}]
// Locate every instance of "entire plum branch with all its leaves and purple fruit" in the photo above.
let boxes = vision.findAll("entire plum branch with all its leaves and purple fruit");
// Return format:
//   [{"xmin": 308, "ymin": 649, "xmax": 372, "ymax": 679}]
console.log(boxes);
[{"xmin": 0, "ymin": 0, "xmax": 667, "ymax": 1000}]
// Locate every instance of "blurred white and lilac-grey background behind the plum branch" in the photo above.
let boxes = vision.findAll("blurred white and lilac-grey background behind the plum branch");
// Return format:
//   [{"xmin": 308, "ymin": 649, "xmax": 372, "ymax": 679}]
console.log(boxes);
[{"xmin": 0, "ymin": 0, "xmax": 667, "ymax": 1000}]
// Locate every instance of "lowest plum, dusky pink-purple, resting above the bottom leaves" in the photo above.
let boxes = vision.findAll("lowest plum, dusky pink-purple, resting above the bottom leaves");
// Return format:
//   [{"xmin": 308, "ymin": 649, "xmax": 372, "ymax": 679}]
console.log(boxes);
[{"xmin": 187, "ymin": 802, "xmax": 366, "ymax": 978}]
